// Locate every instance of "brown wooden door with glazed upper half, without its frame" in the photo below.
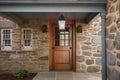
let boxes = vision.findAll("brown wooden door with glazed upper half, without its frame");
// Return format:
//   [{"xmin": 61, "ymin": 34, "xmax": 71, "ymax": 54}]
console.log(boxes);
[{"xmin": 53, "ymin": 25, "xmax": 72, "ymax": 70}]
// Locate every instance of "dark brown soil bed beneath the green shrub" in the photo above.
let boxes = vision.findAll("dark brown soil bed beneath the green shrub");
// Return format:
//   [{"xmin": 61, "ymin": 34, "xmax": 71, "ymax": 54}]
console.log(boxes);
[{"xmin": 0, "ymin": 73, "xmax": 36, "ymax": 80}]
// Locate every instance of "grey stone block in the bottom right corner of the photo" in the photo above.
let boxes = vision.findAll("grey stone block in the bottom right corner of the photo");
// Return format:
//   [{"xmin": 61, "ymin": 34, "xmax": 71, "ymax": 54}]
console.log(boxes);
[{"xmin": 111, "ymin": 67, "xmax": 120, "ymax": 80}]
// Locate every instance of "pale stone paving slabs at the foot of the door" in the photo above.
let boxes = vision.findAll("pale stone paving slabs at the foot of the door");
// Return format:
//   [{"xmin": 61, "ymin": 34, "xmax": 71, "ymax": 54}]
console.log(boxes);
[{"xmin": 33, "ymin": 72, "xmax": 102, "ymax": 80}]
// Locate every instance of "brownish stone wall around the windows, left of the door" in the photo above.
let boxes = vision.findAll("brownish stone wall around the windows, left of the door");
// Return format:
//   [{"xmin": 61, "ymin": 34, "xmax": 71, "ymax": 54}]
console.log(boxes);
[{"xmin": 0, "ymin": 19, "xmax": 49, "ymax": 73}]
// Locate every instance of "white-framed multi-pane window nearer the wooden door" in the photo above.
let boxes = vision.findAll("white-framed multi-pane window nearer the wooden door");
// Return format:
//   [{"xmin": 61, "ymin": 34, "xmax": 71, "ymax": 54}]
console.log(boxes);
[{"xmin": 22, "ymin": 28, "xmax": 32, "ymax": 50}]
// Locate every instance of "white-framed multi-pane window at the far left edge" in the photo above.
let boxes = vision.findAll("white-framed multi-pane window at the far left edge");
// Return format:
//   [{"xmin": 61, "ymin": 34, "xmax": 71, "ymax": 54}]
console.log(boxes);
[{"xmin": 1, "ymin": 29, "xmax": 12, "ymax": 51}]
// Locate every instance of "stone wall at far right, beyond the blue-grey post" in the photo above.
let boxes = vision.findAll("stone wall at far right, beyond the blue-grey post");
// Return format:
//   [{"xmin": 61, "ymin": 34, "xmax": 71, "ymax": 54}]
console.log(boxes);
[{"xmin": 106, "ymin": 0, "xmax": 120, "ymax": 80}]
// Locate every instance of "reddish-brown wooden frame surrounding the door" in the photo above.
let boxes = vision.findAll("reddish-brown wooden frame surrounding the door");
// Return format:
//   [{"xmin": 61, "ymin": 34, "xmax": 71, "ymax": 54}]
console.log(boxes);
[{"xmin": 49, "ymin": 20, "xmax": 76, "ymax": 71}]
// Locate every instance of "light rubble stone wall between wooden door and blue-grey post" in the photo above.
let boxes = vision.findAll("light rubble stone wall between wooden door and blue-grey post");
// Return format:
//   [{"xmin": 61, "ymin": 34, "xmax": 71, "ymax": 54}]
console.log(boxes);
[{"xmin": 76, "ymin": 18, "xmax": 101, "ymax": 72}]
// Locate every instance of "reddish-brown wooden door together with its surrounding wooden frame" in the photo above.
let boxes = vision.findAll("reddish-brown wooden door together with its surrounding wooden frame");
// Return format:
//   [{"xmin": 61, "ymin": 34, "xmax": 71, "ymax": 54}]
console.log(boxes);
[{"xmin": 49, "ymin": 20, "xmax": 76, "ymax": 71}]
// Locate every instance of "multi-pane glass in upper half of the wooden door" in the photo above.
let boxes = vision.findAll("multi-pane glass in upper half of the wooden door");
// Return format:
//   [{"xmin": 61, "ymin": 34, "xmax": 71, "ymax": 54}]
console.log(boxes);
[{"xmin": 55, "ymin": 27, "xmax": 70, "ymax": 46}]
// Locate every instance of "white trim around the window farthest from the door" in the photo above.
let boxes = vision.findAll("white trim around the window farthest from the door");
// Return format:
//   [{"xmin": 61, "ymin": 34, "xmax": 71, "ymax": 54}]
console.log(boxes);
[{"xmin": 1, "ymin": 29, "xmax": 13, "ymax": 51}]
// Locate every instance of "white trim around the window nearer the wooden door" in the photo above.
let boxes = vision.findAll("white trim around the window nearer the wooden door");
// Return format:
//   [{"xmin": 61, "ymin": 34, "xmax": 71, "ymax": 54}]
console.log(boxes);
[{"xmin": 22, "ymin": 28, "xmax": 33, "ymax": 51}]
